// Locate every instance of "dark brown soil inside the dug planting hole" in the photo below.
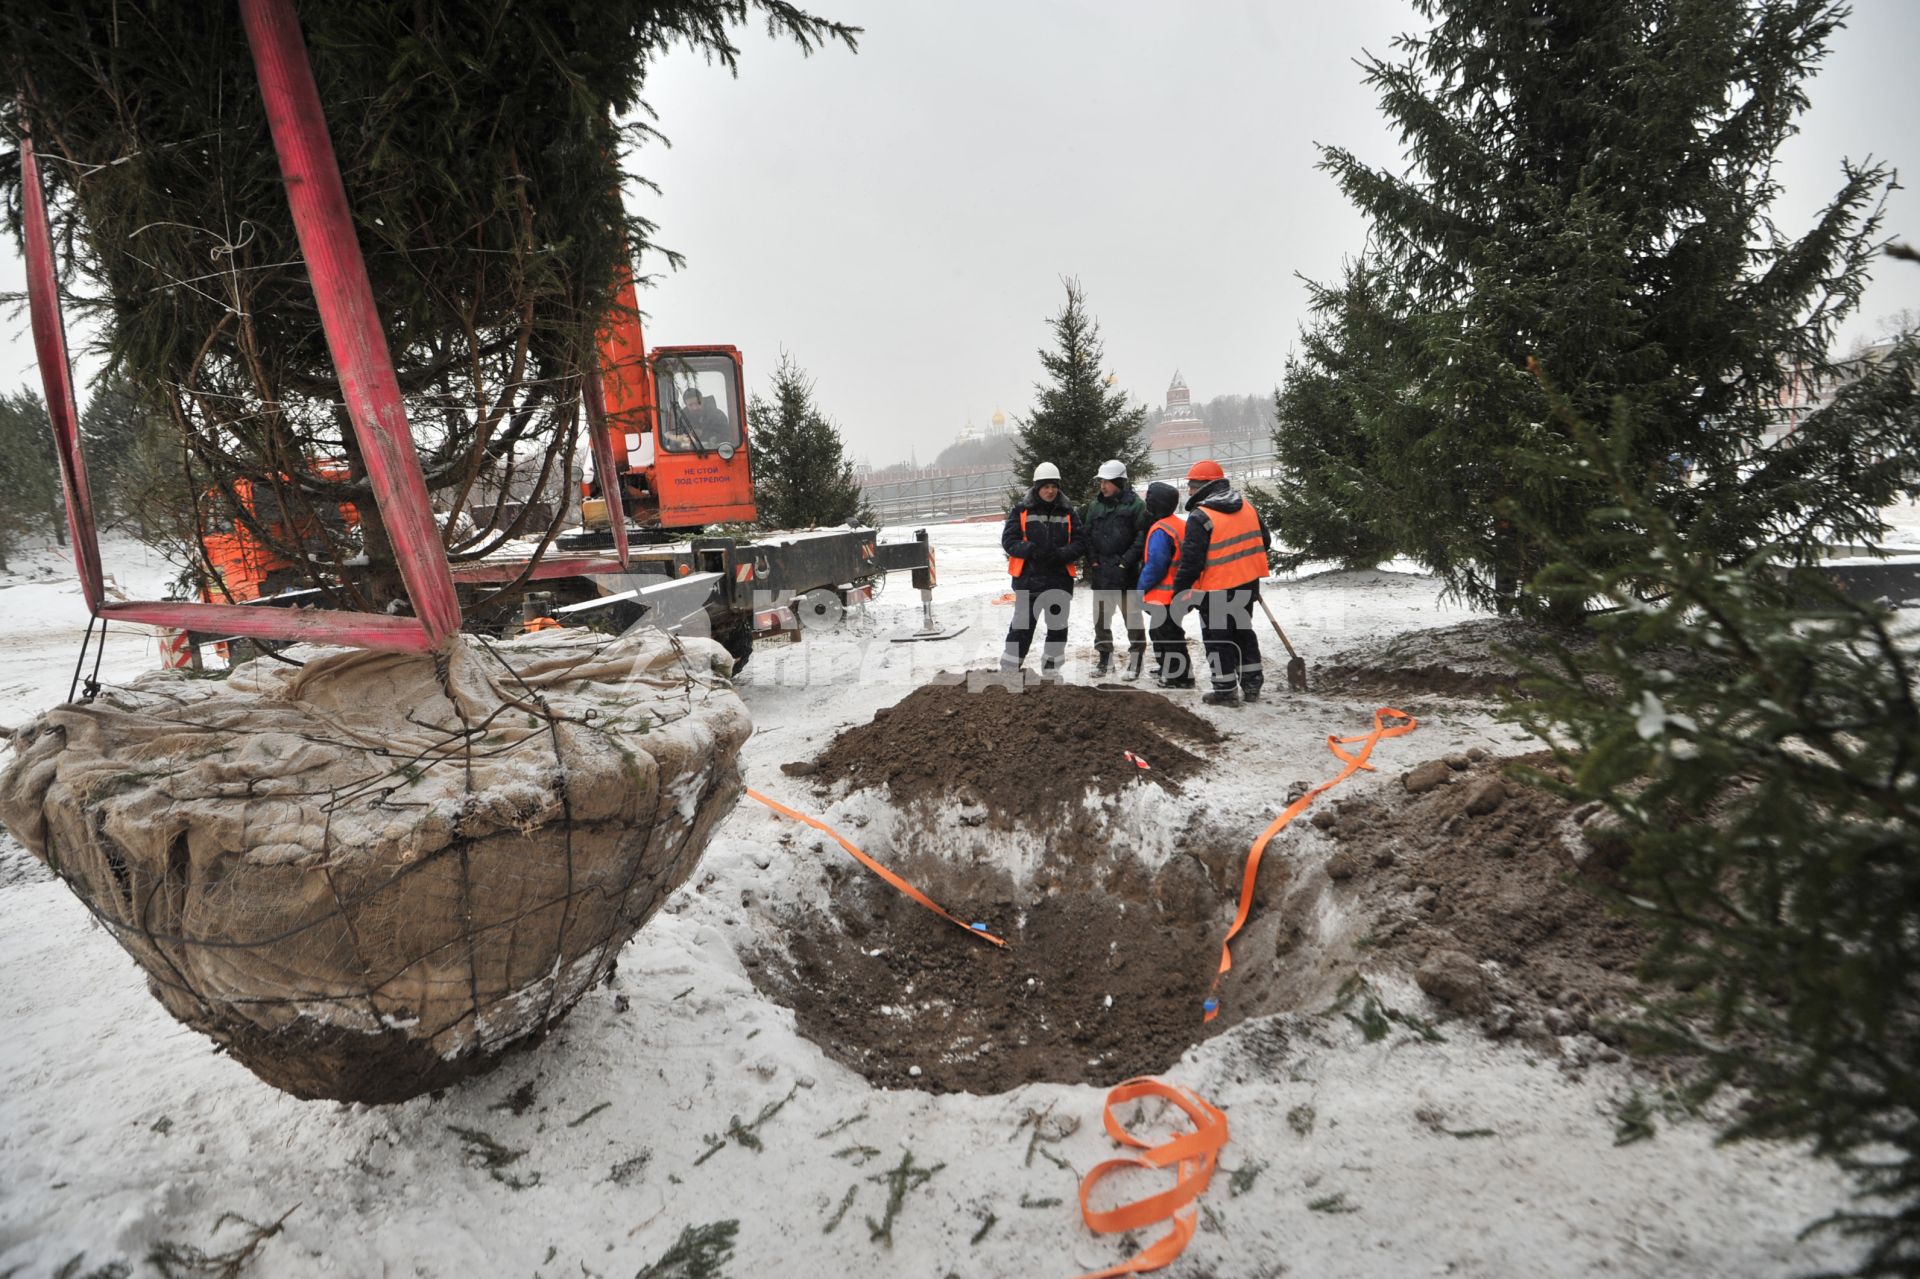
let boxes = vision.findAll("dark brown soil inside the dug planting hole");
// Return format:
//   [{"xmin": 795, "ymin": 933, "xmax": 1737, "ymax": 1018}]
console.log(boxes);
[{"xmin": 749, "ymin": 841, "xmax": 1238, "ymax": 1093}]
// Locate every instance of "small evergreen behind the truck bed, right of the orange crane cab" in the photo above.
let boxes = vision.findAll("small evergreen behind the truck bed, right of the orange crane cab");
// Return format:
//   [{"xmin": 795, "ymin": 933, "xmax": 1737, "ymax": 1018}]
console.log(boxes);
[{"xmin": 747, "ymin": 351, "xmax": 874, "ymax": 528}]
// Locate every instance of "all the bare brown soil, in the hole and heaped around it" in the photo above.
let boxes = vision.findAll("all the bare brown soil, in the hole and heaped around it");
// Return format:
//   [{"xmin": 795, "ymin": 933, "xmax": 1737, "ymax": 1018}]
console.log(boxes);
[{"xmin": 747, "ymin": 656, "xmax": 1674, "ymax": 1093}]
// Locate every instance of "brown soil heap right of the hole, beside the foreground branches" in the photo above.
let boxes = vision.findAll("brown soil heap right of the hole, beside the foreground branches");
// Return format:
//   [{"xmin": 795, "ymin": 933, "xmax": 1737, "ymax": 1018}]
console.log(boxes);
[{"xmin": 1313, "ymin": 751, "xmax": 1649, "ymax": 1056}]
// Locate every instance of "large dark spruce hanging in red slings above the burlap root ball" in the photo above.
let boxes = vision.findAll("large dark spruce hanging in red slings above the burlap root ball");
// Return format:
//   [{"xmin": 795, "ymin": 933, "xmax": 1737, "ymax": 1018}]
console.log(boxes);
[{"xmin": 0, "ymin": 0, "xmax": 858, "ymax": 609}]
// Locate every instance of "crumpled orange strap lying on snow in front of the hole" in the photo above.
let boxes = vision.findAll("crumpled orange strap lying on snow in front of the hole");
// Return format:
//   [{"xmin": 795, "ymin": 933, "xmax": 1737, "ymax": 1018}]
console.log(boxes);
[{"xmin": 1079, "ymin": 1077, "xmax": 1227, "ymax": 1279}]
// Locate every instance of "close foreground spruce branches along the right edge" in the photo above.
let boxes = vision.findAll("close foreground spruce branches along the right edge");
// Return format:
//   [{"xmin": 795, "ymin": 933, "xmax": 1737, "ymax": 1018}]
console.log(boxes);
[{"xmin": 1511, "ymin": 336, "xmax": 1920, "ymax": 1275}]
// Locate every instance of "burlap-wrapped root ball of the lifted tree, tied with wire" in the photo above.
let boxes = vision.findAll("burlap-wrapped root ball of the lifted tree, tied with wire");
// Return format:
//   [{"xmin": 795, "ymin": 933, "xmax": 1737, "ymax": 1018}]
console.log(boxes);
[{"xmin": 0, "ymin": 632, "xmax": 751, "ymax": 1102}]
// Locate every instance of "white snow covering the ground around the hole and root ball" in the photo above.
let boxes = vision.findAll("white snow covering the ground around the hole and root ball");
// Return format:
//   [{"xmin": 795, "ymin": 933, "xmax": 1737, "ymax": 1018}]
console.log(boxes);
[{"xmin": 0, "ymin": 509, "xmax": 1881, "ymax": 1279}]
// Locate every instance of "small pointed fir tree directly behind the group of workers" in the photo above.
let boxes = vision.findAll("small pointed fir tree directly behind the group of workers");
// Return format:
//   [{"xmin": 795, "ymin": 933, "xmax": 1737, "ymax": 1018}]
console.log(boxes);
[{"xmin": 1014, "ymin": 280, "xmax": 1148, "ymax": 505}]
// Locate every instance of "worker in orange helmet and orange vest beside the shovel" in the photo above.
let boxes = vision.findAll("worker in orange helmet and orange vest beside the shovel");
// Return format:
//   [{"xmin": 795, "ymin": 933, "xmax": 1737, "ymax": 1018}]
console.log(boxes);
[{"xmin": 1173, "ymin": 459, "xmax": 1273, "ymax": 707}]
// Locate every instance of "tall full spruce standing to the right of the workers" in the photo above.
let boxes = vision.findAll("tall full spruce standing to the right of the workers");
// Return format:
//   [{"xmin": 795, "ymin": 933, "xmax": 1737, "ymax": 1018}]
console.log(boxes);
[{"xmin": 1279, "ymin": 0, "xmax": 1891, "ymax": 616}]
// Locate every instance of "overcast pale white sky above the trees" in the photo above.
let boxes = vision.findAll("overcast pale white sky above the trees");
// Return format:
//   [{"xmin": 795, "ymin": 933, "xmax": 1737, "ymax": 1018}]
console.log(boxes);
[{"xmin": 0, "ymin": 0, "xmax": 1920, "ymax": 465}]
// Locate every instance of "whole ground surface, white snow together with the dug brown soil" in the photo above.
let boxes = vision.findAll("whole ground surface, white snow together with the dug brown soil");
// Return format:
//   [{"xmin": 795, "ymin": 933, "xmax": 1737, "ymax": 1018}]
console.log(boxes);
[{"xmin": 0, "ymin": 513, "xmax": 1910, "ymax": 1279}]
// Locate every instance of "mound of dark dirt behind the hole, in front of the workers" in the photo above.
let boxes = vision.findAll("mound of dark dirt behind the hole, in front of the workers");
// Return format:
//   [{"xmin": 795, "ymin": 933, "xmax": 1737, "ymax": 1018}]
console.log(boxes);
[{"xmin": 785, "ymin": 674, "xmax": 1221, "ymax": 824}]
